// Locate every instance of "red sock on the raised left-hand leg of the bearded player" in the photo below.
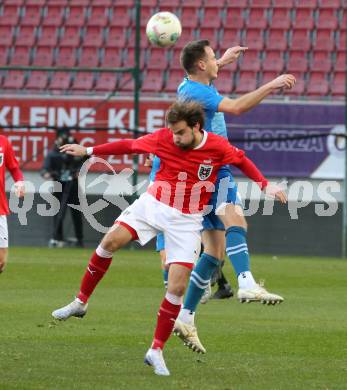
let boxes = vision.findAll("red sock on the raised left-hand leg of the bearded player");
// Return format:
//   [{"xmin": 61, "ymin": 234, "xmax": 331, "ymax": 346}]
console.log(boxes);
[{"xmin": 77, "ymin": 251, "xmax": 112, "ymax": 303}]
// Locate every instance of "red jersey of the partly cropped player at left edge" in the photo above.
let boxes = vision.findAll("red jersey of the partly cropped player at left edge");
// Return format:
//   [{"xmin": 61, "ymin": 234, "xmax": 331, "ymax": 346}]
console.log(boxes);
[{"xmin": 0, "ymin": 135, "xmax": 23, "ymax": 215}]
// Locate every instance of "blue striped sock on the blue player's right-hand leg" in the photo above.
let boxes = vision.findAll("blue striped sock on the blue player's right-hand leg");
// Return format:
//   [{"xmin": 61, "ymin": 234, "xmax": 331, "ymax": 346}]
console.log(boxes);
[{"xmin": 225, "ymin": 226, "xmax": 249, "ymax": 276}]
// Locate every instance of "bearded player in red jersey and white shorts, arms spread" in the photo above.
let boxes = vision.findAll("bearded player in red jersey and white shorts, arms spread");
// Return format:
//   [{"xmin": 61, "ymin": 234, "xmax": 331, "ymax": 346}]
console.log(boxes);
[{"xmin": 52, "ymin": 102, "xmax": 286, "ymax": 375}]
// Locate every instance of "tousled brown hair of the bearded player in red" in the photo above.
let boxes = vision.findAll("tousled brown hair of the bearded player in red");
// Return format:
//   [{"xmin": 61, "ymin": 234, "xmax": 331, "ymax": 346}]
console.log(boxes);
[{"xmin": 166, "ymin": 100, "xmax": 205, "ymax": 129}]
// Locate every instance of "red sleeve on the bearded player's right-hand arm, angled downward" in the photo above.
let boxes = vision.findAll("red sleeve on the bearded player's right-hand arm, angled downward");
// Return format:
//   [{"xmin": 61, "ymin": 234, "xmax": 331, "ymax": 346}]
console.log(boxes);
[{"xmin": 223, "ymin": 141, "xmax": 268, "ymax": 189}]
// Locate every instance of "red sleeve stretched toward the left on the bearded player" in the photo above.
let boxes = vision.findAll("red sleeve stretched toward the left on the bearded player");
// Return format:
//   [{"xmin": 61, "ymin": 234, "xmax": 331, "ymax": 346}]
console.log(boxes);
[{"xmin": 93, "ymin": 132, "xmax": 158, "ymax": 156}]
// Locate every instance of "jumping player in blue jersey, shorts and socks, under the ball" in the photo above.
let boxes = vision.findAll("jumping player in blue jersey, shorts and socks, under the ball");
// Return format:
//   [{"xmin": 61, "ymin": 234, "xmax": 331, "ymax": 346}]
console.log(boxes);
[{"xmin": 171, "ymin": 40, "xmax": 295, "ymax": 353}]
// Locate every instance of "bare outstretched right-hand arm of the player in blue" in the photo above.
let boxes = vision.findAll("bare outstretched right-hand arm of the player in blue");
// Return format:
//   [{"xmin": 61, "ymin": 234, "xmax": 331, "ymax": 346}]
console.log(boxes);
[{"xmin": 218, "ymin": 74, "xmax": 296, "ymax": 115}]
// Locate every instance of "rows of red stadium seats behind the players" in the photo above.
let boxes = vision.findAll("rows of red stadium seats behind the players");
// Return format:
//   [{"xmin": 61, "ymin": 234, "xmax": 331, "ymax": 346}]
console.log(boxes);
[{"xmin": 0, "ymin": 0, "xmax": 347, "ymax": 98}]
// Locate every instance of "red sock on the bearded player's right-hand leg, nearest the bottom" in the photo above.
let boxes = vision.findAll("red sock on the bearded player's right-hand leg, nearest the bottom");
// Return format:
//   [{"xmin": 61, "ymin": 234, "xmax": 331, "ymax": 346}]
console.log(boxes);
[{"xmin": 152, "ymin": 297, "xmax": 181, "ymax": 349}]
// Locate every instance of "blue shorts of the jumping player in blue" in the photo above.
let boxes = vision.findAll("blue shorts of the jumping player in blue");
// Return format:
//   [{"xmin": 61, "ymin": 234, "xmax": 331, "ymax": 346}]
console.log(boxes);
[{"xmin": 202, "ymin": 166, "xmax": 243, "ymax": 230}]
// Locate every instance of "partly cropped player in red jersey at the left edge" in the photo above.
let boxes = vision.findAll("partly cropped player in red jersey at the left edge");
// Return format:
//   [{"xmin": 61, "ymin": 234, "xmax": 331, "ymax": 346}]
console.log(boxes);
[{"xmin": 0, "ymin": 135, "xmax": 25, "ymax": 273}]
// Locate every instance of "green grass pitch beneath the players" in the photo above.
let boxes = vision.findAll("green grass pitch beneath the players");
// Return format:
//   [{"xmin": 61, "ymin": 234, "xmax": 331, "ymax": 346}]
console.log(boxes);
[{"xmin": 0, "ymin": 248, "xmax": 347, "ymax": 390}]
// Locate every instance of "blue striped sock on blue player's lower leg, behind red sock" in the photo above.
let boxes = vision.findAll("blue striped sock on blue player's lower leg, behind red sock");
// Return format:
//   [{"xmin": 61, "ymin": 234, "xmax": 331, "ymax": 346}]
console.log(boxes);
[{"xmin": 183, "ymin": 253, "xmax": 219, "ymax": 312}]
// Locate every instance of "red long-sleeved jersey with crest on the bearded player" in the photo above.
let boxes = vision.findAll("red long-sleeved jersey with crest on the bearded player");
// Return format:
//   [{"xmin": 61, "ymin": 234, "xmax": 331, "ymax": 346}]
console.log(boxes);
[{"xmin": 93, "ymin": 128, "xmax": 267, "ymax": 214}]
